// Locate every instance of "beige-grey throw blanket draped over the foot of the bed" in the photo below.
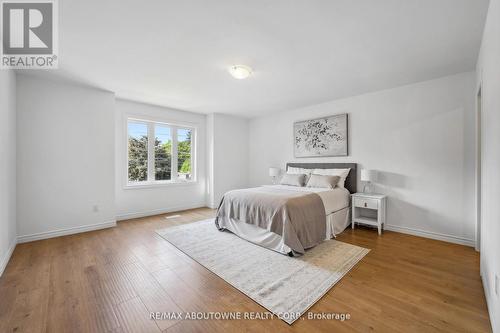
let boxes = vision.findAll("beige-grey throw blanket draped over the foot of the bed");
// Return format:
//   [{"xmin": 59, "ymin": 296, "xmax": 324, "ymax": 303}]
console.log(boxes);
[{"xmin": 215, "ymin": 187, "xmax": 326, "ymax": 254}]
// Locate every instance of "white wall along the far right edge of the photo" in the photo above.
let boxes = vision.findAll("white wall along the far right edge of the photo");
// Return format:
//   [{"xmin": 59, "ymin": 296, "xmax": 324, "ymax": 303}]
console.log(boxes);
[{"xmin": 477, "ymin": 0, "xmax": 500, "ymax": 332}]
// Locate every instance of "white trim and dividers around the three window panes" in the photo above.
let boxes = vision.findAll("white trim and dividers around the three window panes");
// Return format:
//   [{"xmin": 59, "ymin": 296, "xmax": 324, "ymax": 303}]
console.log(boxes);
[{"xmin": 122, "ymin": 115, "xmax": 198, "ymax": 189}]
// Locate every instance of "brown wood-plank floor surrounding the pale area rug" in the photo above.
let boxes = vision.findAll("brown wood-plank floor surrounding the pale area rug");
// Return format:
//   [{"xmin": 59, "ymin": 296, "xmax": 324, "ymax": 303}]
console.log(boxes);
[{"xmin": 0, "ymin": 209, "xmax": 491, "ymax": 333}]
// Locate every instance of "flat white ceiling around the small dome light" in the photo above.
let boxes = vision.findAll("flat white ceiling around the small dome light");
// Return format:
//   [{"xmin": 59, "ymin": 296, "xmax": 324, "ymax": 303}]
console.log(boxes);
[{"xmin": 49, "ymin": 0, "xmax": 488, "ymax": 117}]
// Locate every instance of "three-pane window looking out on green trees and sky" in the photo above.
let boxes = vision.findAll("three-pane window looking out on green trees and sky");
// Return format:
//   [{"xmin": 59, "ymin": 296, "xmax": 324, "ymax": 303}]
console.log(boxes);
[{"xmin": 127, "ymin": 119, "xmax": 195, "ymax": 185}]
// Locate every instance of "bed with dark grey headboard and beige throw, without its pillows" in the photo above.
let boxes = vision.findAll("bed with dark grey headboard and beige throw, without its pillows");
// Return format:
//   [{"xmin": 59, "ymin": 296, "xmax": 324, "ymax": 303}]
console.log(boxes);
[{"xmin": 215, "ymin": 163, "xmax": 357, "ymax": 256}]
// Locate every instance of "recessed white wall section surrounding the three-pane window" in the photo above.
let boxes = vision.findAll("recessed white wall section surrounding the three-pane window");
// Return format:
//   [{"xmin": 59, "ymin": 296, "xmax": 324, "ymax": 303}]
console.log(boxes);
[{"xmin": 115, "ymin": 99, "xmax": 207, "ymax": 220}]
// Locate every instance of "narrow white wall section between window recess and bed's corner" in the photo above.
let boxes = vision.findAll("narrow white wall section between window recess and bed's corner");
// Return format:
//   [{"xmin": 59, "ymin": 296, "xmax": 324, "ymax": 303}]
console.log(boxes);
[{"xmin": 207, "ymin": 113, "xmax": 249, "ymax": 208}]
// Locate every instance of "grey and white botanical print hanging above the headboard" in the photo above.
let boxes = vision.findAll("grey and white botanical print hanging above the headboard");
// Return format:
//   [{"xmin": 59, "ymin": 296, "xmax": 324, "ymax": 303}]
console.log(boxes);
[{"xmin": 293, "ymin": 113, "xmax": 347, "ymax": 157}]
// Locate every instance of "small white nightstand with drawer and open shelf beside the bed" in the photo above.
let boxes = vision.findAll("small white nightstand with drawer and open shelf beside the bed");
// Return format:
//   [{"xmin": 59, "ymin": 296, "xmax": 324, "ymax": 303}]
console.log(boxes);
[{"xmin": 352, "ymin": 193, "xmax": 387, "ymax": 235}]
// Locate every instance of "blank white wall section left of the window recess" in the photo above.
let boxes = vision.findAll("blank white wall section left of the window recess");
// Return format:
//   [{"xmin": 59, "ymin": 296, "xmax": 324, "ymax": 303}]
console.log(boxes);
[{"xmin": 17, "ymin": 75, "xmax": 115, "ymax": 241}]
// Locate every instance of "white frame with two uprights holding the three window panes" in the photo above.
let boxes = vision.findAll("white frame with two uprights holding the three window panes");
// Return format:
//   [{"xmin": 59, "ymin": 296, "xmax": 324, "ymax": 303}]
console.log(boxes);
[{"xmin": 123, "ymin": 115, "xmax": 198, "ymax": 189}]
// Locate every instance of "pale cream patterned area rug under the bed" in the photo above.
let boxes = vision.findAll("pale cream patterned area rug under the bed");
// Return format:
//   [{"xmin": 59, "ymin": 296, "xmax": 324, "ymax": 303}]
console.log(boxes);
[{"xmin": 157, "ymin": 219, "xmax": 369, "ymax": 324}]
